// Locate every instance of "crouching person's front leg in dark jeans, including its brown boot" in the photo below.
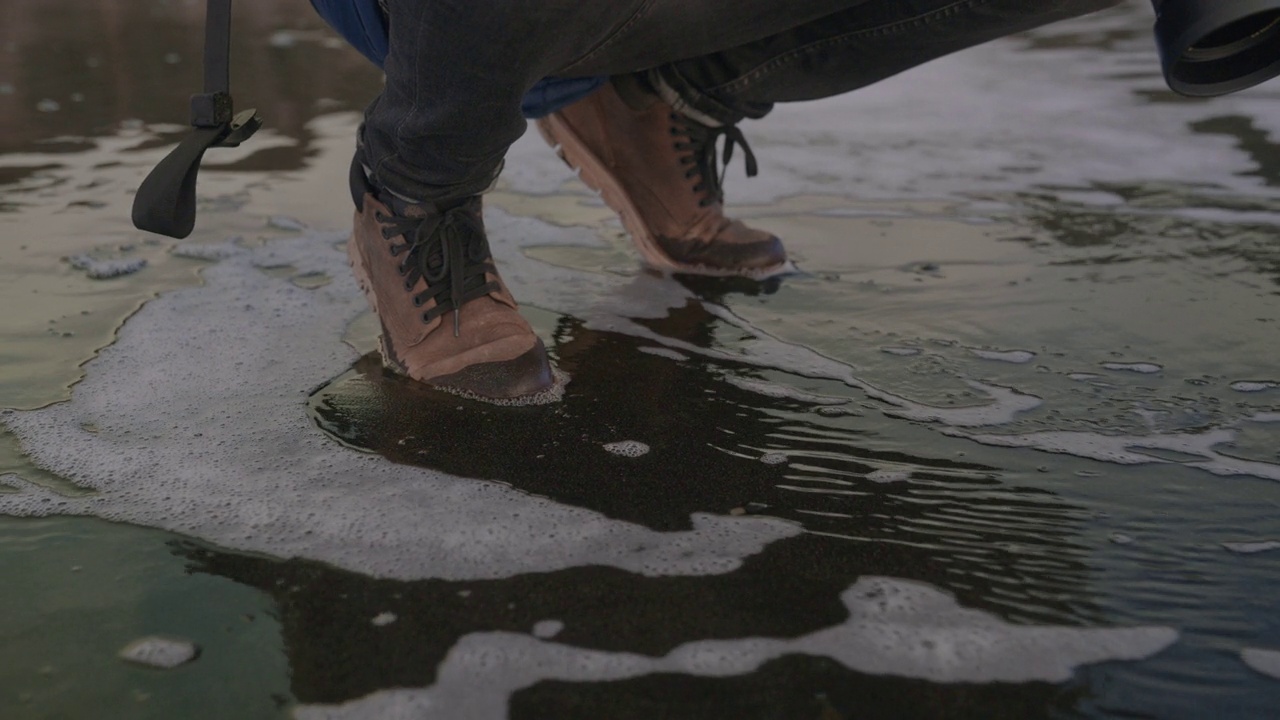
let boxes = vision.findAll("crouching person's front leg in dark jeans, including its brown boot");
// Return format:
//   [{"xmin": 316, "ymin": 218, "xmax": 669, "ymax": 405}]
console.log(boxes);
[{"xmin": 349, "ymin": 0, "xmax": 650, "ymax": 400}]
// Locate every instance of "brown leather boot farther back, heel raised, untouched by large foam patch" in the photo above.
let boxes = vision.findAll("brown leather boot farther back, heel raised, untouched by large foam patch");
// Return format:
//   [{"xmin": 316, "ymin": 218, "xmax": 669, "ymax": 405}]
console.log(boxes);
[{"xmin": 538, "ymin": 82, "xmax": 787, "ymax": 278}]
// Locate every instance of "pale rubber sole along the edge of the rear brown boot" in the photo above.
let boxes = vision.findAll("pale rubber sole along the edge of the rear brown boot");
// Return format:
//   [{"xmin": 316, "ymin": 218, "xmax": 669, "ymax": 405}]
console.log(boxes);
[{"xmin": 536, "ymin": 114, "xmax": 791, "ymax": 279}]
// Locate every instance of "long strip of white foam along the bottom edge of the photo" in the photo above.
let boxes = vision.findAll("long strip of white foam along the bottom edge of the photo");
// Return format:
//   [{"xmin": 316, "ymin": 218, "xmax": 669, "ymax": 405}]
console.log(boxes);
[{"xmin": 296, "ymin": 577, "xmax": 1178, "ymax": 720}]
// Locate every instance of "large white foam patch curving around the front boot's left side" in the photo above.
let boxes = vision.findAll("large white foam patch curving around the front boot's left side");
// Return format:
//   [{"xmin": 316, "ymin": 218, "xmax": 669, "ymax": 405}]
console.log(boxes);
[{"xmin": 0, "ymin": 226, "xmax": 800, "ymax": 580}]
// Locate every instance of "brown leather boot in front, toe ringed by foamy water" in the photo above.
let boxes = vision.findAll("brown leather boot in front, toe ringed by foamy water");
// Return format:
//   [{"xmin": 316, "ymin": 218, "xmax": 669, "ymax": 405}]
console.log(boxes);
[{"xmin": 347, "ymin": 155, "xmax": 554, "ymax": 400}]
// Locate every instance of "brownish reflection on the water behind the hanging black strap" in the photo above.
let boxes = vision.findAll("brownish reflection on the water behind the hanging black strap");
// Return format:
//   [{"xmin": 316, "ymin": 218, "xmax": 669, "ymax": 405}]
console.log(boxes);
[{"xmin": 0, "ymin": 0, "xmax": 381, "ymax": 159}]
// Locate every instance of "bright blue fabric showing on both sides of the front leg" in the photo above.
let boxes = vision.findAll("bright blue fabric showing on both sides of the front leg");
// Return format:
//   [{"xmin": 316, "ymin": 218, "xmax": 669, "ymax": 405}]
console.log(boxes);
[{"xmin": 311, "ymin": 0, "xmax": 605, "ymax": 118}]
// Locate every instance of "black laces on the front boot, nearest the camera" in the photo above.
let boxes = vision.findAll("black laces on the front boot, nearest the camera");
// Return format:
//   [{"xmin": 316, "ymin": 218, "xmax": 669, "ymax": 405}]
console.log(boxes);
[{"xmin": 376, "ymin": 205, "xmax": 498, "ymax": 337}]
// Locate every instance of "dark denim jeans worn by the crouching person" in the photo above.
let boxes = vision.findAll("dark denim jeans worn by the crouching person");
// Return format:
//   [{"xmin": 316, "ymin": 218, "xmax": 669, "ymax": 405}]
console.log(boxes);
[{"xmin": 361, "ymin": 0, "xmax": 1120, "ymax": 201}]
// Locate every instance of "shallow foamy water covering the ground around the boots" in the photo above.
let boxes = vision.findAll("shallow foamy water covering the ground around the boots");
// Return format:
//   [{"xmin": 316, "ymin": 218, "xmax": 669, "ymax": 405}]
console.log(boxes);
[{"xmin": 0, "ymin": 0, "xmax": 1280, "ymax": 720}]
